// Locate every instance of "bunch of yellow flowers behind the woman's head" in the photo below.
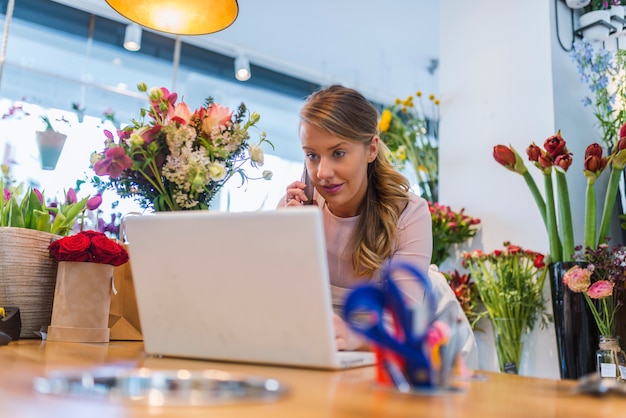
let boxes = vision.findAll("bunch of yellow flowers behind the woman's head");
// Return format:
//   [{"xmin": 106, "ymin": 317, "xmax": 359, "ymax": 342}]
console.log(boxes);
[{"xmin": 378, "ymin": 91, "xmax": 439, "ymax": 202}]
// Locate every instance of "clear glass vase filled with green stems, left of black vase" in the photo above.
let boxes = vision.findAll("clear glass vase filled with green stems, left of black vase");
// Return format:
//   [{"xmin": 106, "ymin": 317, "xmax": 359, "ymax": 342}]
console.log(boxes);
[{"xmin": 491, "ymin": 318, "xmax": 524, "ymax": 374}]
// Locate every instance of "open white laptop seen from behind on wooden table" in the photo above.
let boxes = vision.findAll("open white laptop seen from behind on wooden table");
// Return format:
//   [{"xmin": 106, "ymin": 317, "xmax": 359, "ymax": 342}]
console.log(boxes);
[{"xmin": 125, "ymin": 206, "xmax": 375, "ymax": 369}]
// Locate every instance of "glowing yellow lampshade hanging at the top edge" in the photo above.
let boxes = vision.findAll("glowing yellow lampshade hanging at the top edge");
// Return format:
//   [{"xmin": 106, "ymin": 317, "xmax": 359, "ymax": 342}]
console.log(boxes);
[{"xmin": 106, "ymin": 0, "xmax": 239, "ymax": 35}]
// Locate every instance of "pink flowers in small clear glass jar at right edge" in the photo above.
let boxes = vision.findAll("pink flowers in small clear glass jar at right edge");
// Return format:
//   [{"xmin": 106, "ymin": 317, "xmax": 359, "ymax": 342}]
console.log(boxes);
[{"xmin": 563, "ymin": 243, "xmax": 626, "ymax": 379}]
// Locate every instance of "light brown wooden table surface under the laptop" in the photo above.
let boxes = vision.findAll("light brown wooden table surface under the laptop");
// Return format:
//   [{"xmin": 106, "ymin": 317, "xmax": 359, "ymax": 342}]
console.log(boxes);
[{"xmin": 0, "ymin": 340, "xmax": 626, "ymax": 418}]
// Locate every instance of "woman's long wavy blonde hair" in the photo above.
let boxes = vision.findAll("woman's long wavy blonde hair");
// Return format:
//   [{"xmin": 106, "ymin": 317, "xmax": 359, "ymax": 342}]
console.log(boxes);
[{"xmin": 300, "ymin": 85, "xmax": 410, "ymax": 277}]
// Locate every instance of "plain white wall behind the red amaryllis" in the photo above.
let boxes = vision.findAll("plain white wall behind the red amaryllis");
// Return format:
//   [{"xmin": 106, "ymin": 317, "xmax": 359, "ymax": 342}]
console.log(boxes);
[{"xmin": 439, "ymin": 0, "xmax": 584, "ymax": 378}]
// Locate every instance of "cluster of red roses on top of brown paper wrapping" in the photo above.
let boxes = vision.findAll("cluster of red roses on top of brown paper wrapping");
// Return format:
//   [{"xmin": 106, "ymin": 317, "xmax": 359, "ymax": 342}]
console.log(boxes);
[{"xmin": 48, "ymin": 230, "xmax": 128, "ymax": 267}]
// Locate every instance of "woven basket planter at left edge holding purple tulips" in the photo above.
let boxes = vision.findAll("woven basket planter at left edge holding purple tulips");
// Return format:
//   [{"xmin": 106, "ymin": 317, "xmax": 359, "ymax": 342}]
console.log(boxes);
[{"xmin": 0, "ymin": 227, "xmax": 58, "ymax": 338}]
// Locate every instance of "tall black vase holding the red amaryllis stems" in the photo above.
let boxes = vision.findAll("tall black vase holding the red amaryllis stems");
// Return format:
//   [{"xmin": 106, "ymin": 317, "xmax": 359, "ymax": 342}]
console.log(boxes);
[{"xmin": 548, "ymin": 262, "xmax": 599, "ymax": 379}]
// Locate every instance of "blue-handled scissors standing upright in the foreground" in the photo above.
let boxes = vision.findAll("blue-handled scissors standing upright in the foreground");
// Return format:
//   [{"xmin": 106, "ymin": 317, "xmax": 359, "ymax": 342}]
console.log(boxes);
[{"xmin": 344, "ymin": 262, "xmax": 437, "ymax": 387}]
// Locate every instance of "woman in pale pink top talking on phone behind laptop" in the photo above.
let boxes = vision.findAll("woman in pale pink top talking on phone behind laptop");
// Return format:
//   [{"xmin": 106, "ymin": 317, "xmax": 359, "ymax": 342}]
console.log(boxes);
[{"xmin": 279, "ymin": 85, "xmax": 432, "ymax": 350}]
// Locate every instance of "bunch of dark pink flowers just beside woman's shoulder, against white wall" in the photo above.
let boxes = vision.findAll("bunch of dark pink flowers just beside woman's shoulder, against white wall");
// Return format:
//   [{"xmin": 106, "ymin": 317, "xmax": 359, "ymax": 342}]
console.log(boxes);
[{"xmin": 428, "ymin": 202, "xmax": 480, "ymax": 266}]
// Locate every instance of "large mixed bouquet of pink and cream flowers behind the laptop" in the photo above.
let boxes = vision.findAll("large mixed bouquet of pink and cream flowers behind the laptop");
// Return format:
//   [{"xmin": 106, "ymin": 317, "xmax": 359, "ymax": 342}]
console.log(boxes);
[{"xmin": 91, "ymin": 83, "xmax": 272, "ymax": 211}]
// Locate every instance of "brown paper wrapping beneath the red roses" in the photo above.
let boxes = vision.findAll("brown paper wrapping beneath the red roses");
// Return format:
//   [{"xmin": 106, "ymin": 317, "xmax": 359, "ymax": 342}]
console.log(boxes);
[{"xmin": 48, "ymin": 261, "xmax": 114, "ymax": 343}]
